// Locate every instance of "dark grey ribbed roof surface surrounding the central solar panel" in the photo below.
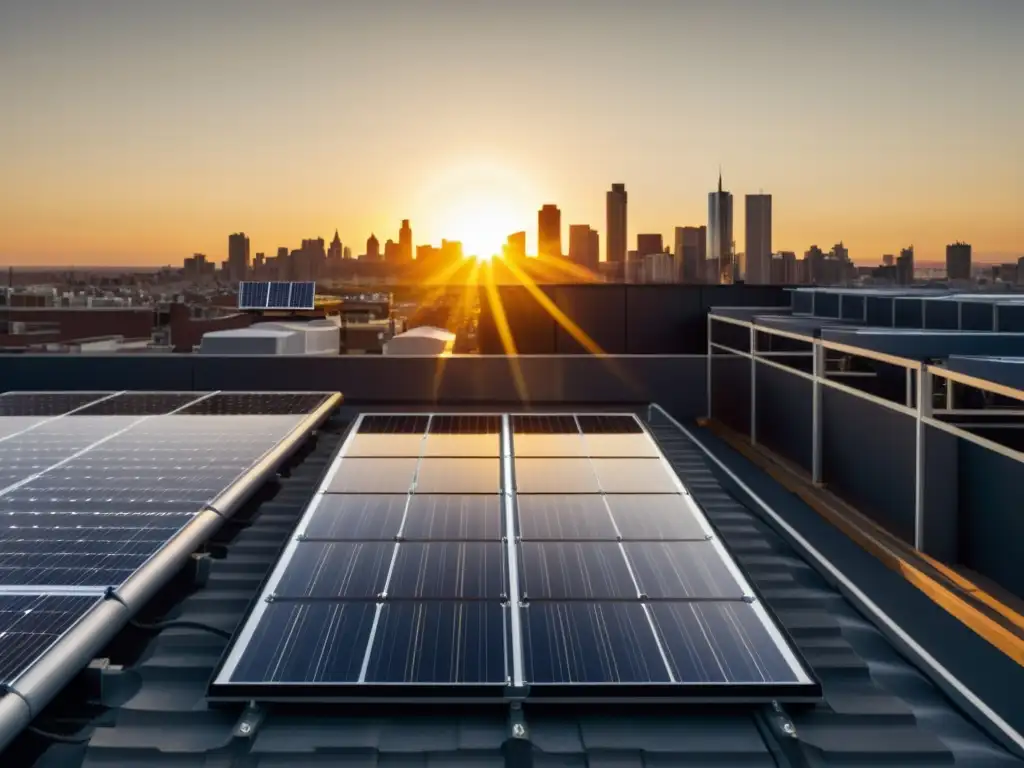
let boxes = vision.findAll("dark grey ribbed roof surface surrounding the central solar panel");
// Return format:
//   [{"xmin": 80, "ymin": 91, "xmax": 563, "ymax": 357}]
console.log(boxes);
[{"xmin": 6, "ymin": 415, "xmax": 1017, "ymax": 768}]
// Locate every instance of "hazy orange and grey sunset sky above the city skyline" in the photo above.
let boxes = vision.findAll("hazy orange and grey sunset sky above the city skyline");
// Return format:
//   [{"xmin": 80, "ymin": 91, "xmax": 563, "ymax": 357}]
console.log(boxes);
[{"xmin": 0, "ymin": 0, "xmax": 1024, "ymax": 264}]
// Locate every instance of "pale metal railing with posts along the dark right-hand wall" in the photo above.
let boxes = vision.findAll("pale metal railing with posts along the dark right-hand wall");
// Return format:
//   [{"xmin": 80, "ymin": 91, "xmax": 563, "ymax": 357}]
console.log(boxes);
[{"xmin": 707, "ymin": 310, "xmax": 1024, "ymax": 550}]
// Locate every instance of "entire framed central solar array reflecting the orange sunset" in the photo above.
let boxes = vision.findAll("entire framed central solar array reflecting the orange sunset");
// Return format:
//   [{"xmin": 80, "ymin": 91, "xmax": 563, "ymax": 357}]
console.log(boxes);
[{"xmin": 211, "ymin": 414, "xmax": 819, "ymax": 701}]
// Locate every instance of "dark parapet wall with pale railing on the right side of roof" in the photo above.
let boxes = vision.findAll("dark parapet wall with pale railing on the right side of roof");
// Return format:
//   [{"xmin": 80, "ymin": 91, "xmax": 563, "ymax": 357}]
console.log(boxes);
[{"xmin": 708, "ymin": 315, "xmax": 1024, "ymax": 597}]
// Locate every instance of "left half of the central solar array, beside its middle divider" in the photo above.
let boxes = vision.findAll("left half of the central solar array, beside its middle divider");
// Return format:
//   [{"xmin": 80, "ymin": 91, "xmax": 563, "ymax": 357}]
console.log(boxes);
[{"xmin": 223, "ymin": 415, "xmax": 509, "ymax": 695}]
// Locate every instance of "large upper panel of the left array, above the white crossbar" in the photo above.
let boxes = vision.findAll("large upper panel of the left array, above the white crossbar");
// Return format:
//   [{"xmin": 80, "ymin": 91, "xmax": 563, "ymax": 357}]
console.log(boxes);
[{"xmin": 0, "ymin": 393, "xmax": 339, "ymax": 591}]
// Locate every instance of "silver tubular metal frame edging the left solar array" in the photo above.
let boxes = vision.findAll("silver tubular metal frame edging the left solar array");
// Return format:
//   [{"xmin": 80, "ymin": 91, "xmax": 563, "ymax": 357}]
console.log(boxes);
[{"xmin": 0, "ymin": 390, "xmax": 341, "ymax": 752}]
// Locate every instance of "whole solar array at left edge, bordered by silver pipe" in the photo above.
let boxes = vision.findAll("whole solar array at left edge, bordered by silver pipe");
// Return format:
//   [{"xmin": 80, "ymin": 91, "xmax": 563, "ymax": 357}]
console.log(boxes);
[{"xmin": 0, "ymin": 392, "xmax": 330, "ymax": 685}]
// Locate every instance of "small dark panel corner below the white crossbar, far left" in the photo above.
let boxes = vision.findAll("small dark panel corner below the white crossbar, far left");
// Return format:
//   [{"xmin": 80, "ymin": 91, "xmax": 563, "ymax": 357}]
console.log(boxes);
[{"xmin": 0, "ymin": 595, "xmax": 100, "ymax": 684}]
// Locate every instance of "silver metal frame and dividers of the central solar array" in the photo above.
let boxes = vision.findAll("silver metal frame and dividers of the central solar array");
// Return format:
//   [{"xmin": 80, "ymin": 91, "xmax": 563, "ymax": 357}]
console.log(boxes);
[{"xmin": 208, "ymin": 411, "xmax": 820, "ymax": 703}]
